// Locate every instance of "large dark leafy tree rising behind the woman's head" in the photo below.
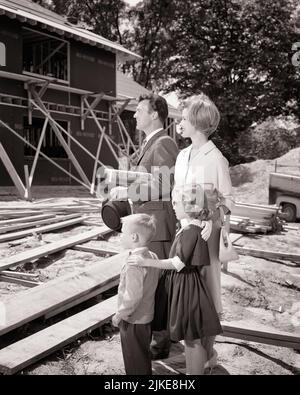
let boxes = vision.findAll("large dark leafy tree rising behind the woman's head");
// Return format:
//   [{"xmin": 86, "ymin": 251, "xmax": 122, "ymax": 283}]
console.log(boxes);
[{"xmin": 162, "ymin": 0, "xmax": 299, "ymax": 163}]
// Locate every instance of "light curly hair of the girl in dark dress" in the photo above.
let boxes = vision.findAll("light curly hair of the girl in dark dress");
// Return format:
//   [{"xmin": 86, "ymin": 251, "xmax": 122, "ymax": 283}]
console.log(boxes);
[{"xmin": 172, "ymin": 184, "xmax": 212, "ymax": 221}]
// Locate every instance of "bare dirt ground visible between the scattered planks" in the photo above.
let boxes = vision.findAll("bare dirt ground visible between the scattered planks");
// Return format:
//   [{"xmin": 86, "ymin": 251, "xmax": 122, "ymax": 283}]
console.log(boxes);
[{"xmin": 0, "ymin": 150, "xmax": 300, "ymax": 375}]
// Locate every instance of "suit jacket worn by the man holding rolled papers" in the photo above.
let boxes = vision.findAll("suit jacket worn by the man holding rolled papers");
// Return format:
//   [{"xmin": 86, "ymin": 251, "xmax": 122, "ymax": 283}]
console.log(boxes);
[{"xmin": 129, "ymin": 130, "xmax": 179, "ymax": 246}]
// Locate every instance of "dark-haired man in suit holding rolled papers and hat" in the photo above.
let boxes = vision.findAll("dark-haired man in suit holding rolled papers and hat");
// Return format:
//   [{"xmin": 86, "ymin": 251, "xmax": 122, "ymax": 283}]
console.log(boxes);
[{"xmin": 111, "ymin": 94, "xmax": 178, "ymax": 359}]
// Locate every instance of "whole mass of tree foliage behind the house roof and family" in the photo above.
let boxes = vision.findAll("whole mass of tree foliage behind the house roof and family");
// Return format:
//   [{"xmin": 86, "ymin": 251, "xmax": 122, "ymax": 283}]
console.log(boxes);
[{"xmin": 31, "ymin": 0, "xmax": 300, "ymax": 164}]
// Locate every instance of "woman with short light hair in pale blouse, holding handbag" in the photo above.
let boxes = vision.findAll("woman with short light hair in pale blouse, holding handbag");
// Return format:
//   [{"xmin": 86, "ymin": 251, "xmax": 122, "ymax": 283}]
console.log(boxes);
[{"xmin": 175, "ymin": 94, "xmax": 233, "ymax": 367}]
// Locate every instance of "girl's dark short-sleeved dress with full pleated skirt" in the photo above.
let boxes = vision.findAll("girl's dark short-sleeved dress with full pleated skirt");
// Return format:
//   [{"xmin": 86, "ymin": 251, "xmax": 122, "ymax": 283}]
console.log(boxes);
[{"xmin": 152, "ymin": 224, "xmax": 222, "ymax": 341}]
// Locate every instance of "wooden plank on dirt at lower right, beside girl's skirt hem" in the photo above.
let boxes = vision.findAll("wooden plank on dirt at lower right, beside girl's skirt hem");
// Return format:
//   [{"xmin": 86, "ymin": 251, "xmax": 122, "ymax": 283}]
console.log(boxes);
[{"xmin": 220, "ymin": 321, "xmax": 300, "ymax": 350}]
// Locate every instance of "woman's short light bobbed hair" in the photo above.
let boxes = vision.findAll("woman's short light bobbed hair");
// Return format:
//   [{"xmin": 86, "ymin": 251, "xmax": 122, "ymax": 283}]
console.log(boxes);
[{"xmin": 182, "ymin": 93, "xmax": 220, "ymax": 137}]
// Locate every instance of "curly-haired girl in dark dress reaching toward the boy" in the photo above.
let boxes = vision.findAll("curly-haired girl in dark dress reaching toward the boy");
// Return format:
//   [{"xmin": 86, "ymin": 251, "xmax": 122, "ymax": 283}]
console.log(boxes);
[{"xmin": 127, "ymin": 185, "xmax": 222, "ymax": 374}]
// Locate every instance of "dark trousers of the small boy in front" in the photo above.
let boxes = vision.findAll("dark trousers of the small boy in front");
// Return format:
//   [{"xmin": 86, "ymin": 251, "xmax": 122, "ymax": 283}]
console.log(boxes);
[{"xmin": 119, "ymin": 320, "xmax": 152, "ymax": 375}]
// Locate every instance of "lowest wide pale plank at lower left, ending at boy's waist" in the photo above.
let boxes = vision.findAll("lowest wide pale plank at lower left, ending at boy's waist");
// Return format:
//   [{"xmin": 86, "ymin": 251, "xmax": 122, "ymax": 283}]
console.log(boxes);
[{"xmin": 0, "ymin": 296, "xmax": 117, "ymax": 374}]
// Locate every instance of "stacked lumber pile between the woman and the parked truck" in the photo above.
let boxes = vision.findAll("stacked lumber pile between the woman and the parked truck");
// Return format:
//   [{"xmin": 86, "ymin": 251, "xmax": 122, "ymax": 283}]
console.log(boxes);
[{"xmin": 230, "ymin": 202, "xmax": 283, "ymax": 233}]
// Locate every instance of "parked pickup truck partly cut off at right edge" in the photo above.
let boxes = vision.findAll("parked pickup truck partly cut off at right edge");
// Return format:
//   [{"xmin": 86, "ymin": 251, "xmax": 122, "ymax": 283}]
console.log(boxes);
[{"xmin": 269, "ymin": 173, "xmax": 300, "ymax": 222}]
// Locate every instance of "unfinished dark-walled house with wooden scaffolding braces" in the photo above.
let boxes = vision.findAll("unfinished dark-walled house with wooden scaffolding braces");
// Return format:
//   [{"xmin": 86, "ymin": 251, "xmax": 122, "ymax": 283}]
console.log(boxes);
[{"xmin": 0, "ymin": 0, "xmax": 180, "ymax": 198}]
